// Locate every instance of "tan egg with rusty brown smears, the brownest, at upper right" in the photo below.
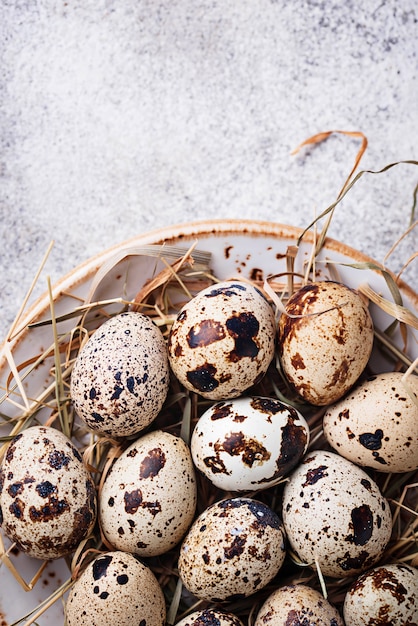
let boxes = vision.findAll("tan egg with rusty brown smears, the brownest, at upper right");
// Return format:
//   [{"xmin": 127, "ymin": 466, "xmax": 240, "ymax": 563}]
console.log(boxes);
[{"xmin": 278, "ymin": 281, "xmax": 373, "ymax": 405}]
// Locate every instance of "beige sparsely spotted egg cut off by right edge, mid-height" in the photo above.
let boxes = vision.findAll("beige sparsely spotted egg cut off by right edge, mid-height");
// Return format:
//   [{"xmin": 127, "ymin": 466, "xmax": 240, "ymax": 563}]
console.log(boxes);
[{"xmin": 323, "ymin": 372, "xmax": 418, "ymax": 473}]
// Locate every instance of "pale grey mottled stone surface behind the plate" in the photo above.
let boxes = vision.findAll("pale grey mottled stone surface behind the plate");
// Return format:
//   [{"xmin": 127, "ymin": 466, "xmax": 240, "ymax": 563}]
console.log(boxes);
[{"xmin": 0, "ymin": 0, "xmax": 418, "ymax": 336}]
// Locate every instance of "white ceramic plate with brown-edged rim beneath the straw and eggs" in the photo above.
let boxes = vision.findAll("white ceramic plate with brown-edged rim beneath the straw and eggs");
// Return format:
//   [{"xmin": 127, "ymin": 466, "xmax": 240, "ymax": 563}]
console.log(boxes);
[{"xmin": 0, "ymin": 220, "xmax": 418, "ymax": 625}]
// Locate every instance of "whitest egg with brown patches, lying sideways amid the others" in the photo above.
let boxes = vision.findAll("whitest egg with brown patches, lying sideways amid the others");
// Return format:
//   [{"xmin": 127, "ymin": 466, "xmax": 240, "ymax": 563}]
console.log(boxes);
[{"xmin": 191, "ymin": 396, "xmax": 309, "ymax": 492}]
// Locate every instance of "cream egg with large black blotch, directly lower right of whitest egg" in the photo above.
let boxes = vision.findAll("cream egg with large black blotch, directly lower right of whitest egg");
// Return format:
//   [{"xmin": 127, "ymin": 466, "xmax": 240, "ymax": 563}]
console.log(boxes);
[{"xmin": 282, "ymin": 450, "xmax": 392, "ymax": 578}]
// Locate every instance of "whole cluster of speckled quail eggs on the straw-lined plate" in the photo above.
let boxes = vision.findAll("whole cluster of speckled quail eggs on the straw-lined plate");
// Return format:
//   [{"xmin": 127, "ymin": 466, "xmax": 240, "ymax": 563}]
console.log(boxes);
[{"xmin": 0, "ymin": 281, "xmax": 418, "ymax": 626}]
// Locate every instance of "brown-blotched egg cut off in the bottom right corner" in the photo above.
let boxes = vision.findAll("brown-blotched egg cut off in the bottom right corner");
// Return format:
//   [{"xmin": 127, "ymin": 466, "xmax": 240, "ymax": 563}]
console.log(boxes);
[{"xmin": 343, "ymin": 563, "xmax": 418, "ymax": 626}]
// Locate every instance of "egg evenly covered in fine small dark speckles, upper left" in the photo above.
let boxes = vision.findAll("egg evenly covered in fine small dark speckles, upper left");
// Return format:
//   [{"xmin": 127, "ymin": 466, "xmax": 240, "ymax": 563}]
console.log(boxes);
[{"xmin": 71, "ymin": 312, "xmax": 169, "ymax": 437}]
